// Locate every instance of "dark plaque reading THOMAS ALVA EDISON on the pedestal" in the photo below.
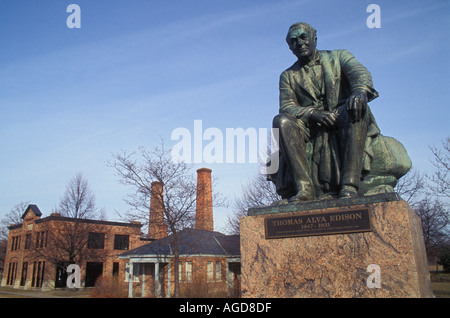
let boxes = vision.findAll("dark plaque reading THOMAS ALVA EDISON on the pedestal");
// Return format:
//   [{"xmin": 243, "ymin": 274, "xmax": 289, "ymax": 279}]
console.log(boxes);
[{"xmin": 264, "ymin": 209, "xmax": 372, "ymax": 239}]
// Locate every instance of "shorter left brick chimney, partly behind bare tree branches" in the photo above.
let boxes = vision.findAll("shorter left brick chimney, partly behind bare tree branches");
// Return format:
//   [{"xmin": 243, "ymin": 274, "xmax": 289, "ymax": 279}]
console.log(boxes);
[{"xmin": 148, "ymin": 181, "xmax": 167, "ymax": 240}]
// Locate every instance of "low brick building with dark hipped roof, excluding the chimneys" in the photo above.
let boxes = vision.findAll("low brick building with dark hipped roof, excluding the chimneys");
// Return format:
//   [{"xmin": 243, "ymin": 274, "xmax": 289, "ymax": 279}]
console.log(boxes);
[{"xmin": 119, "ymin": 229, "xmax": 240, "ymax": 297}]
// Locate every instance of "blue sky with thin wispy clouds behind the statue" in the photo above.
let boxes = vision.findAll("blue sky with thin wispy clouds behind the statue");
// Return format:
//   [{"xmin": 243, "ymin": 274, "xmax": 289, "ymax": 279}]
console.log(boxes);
[{"xmin": 0, "ymin": 0, "xmax": 450, "ymax": 230}]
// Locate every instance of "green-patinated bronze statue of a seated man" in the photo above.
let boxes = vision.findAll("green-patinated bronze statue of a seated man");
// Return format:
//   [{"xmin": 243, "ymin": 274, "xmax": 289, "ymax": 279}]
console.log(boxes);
[{"xmin": 269, "ymin": 23, "xmax": 411, "ymax": 202}]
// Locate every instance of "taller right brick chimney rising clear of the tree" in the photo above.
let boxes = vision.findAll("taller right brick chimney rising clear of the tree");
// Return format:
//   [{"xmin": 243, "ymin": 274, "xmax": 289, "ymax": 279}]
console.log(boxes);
[{"xmin": 195, "ymin": 168, "xmax": 214, "ymax": 231}]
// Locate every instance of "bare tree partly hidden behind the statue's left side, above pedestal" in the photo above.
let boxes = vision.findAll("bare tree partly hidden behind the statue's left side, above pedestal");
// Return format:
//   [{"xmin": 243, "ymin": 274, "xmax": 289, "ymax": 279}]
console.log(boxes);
[{"xmin": 226, "ymin": 172, "xmax": 281, "ymax": 234}]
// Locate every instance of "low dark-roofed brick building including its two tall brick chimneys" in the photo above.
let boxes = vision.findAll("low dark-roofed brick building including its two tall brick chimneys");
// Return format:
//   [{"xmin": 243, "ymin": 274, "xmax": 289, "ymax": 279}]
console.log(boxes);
[{"xmin": 119, "ymin": 168, "xmax": 241, "ymax": 297}]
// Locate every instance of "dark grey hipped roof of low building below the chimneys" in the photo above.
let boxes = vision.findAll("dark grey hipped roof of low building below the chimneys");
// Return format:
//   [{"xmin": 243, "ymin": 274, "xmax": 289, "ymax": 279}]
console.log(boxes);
[{"xmin": 119, "ymin": 229, "xmax": 241, "ymax": 258}]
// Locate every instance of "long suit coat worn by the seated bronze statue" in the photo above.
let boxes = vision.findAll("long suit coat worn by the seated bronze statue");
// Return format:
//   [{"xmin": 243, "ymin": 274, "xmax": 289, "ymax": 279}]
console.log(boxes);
[{"xmin": 269, "ymin": 50, "xmax": 380, "ymax": 193}]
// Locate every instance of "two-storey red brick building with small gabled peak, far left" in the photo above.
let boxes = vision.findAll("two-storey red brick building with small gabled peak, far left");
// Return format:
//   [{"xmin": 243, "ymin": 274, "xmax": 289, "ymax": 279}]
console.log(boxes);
[{"xmin": 0, "ymin": 204, "xmax": 147, "ymax": 290}]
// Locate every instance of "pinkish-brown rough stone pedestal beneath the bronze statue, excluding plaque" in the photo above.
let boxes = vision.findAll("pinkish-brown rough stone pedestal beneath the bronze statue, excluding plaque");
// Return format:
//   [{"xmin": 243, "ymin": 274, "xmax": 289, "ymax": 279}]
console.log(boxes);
[{"xmin": 241, "ymin": 200, "xmax": 433, "ymax": 298}]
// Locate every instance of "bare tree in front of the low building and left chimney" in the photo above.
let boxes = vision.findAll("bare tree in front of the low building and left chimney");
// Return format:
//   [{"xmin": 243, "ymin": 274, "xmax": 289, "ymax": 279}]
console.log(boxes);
[{"xmin": 108, "ymin": 141, "xmax": 197, "ymax": 297}]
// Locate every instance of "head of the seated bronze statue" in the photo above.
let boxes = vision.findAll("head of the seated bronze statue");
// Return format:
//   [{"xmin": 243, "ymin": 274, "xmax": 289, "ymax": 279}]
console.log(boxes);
[{"xmin": 286, "ymin": 22, "xmax": 317, "ymax": 61}]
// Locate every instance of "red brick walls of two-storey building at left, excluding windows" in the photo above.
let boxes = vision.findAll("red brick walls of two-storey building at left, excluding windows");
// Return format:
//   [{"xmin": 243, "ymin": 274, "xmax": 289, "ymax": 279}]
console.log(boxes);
[{"xmin": 0, "ymin": 212, "xmax": 148, "ymax": 289}]
